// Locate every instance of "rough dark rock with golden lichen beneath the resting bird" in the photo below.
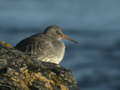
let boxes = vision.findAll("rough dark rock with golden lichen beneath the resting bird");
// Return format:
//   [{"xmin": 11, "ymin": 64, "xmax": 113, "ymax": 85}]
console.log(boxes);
[{"xmin": 0, "ymin": 47, "xmax": 79, "ymax": 90}]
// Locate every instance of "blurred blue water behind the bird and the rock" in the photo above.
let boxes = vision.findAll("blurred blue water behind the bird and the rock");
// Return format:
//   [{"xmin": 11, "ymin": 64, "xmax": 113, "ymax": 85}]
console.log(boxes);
[{"xmin": 0, "ymin": 0, "xmax": 120, "ymax": 90}]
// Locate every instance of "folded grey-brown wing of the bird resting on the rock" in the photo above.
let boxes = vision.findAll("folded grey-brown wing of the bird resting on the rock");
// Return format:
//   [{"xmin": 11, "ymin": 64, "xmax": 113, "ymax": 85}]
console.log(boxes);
[{"xmin": 15, "ymin": 38, "xmax": 56, "ymax": 61}]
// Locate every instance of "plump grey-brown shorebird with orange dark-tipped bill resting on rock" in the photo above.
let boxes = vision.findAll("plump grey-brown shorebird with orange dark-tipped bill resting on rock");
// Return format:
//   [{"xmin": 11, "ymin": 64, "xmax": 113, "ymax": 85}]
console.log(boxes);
[{"xmin": 15, "ymin": 25, "xmax": 78, "ymax": 64}]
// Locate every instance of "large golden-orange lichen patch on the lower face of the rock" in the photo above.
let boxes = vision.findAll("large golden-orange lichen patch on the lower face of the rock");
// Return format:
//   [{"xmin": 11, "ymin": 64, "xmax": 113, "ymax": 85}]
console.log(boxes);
[{"xmin": 4, "ymin": 68, "xmax": 69, "ymax": 90}]
